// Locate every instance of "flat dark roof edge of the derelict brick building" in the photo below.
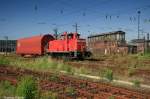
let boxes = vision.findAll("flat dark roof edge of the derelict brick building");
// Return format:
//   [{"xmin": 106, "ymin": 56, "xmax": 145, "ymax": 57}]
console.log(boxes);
[{"xmin": 88, "ymin": 31, "xmax": 125, "ymax": 38}]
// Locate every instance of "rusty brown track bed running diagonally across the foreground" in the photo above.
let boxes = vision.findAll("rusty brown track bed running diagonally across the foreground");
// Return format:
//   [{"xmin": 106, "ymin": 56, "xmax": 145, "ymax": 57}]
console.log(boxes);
[{"xmin": 0, "ymin": 66, "xmax": 150, "ymax": 99}]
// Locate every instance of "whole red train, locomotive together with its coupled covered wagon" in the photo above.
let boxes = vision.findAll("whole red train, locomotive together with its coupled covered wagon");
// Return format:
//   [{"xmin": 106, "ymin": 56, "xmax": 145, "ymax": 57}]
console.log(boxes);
[{"xmin": 16, "ymin": 32, "xmax": 89, "ymax": 58}]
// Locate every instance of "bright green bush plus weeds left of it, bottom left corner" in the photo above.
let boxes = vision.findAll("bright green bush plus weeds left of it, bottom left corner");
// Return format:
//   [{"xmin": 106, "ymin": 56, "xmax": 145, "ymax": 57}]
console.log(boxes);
[{"xmin": 0, "ymin": 77, "xmax": 39, "ymax": 99}]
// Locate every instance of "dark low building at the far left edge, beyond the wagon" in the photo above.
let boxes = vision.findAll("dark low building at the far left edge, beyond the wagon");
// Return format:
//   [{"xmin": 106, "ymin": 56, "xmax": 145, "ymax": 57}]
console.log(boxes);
[{"xmin": 0, "ymin": 40, "xmax": 17, "ymax": 53}]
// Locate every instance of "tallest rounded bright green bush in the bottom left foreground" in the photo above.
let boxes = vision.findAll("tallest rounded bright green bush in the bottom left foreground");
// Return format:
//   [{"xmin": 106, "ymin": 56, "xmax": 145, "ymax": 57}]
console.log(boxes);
[{"xmin": 16, "ymin": 77, "xmax": 38, "ymax": 99}]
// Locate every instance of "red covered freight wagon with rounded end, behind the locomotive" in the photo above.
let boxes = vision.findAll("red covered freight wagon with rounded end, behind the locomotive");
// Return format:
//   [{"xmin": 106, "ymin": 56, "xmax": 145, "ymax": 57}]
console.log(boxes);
[{"xmin": 16, "ymin": 34, "xmax": 54, "ymax": 56}]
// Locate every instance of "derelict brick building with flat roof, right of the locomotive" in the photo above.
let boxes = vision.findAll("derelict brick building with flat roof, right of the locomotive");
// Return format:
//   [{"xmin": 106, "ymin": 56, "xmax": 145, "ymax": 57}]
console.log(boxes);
[{"xmin": 88, "ymin": 31, "xmax": 128, "ymax": 56}]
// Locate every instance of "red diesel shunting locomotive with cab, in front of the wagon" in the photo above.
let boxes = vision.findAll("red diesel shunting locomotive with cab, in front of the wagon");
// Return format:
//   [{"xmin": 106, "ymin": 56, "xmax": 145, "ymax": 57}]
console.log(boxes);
[{"xmin": 48, "ymin": 32, "xmax": 86, "ymax": 58}]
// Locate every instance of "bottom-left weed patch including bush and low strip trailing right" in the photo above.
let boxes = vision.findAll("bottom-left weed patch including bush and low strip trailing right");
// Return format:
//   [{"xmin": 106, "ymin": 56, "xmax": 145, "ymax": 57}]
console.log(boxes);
[{"xmin": 0, "ymin": 76, "xmax": 58, "ymax": 99}]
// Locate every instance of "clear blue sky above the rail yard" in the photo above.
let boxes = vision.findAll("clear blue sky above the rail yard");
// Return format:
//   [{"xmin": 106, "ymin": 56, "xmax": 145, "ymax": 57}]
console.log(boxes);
[{"xmin": 0, "ymin": 0, "xmax": 150, "ymax": 41}]
